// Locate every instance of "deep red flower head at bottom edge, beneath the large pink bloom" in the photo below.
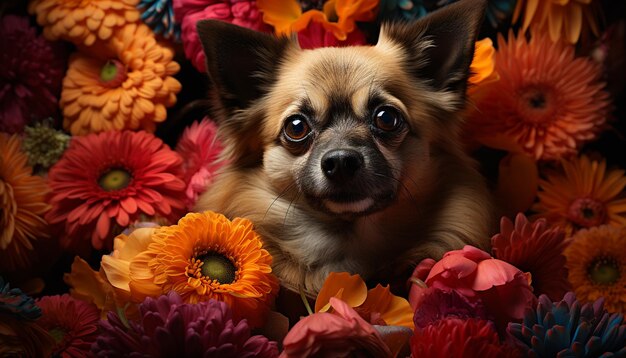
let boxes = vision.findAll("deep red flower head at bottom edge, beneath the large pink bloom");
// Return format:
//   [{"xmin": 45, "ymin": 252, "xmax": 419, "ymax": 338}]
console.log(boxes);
[{"xmin": 411, "ymin": 318, "xmax": 511, "ymax": 358}]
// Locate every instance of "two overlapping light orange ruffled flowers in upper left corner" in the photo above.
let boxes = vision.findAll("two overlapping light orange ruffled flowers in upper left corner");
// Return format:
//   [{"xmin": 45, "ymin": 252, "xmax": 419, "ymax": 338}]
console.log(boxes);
[{"xmin": 29, "ymin": 0, "xmax": 181, "ymax": 135}]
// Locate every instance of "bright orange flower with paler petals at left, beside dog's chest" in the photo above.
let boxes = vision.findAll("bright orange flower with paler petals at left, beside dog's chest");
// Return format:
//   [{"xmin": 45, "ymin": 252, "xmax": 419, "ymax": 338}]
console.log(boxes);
[{"xmin": 102, "ymin": 212, "xmax": 278, "ymax": 326}]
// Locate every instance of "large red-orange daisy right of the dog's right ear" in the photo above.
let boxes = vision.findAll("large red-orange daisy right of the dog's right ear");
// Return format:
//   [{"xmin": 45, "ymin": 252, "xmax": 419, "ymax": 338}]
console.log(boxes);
[{"xmin": 468, "ymin": 32, "xmax": 610, "ymax": 160}]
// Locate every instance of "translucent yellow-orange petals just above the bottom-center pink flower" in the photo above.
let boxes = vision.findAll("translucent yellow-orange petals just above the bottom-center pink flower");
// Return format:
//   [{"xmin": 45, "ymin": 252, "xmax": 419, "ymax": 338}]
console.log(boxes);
[{"xmin": 315, "ymin": 272, "xmax": 415, "ymax": 330}]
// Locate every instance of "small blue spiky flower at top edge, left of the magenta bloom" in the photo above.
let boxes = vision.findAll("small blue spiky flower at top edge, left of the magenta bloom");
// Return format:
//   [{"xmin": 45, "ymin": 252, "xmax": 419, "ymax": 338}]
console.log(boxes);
[{"xmin": 137, "ymin": 0, "xmax": 180, "ymax": 41}]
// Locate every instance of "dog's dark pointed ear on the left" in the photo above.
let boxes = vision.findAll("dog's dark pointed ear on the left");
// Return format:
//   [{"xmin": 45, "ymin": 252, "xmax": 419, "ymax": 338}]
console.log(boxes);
[{"xmin": 196, "ymin": 20, "xmax": 291, "ymax": 115}]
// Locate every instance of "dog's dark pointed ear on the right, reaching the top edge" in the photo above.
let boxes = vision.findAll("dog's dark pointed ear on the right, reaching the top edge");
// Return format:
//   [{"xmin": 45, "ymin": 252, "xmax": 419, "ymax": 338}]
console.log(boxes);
[{"xmin": 379, "ymin": 0, "xmax": 487, "ymax": 95}]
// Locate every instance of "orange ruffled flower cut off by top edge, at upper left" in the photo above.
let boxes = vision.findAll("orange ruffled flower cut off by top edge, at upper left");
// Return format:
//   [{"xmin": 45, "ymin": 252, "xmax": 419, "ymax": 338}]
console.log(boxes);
[{"xmin": 28, "ymin": 0, "xmax": 140, "ymax": 46}]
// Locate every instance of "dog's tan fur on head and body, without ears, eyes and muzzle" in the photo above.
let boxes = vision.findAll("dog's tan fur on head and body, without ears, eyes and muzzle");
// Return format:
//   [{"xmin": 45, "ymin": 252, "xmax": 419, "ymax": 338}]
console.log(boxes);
[{"xmin": 196, "ymin": 24, "xmax": 493, "ymax": 292}]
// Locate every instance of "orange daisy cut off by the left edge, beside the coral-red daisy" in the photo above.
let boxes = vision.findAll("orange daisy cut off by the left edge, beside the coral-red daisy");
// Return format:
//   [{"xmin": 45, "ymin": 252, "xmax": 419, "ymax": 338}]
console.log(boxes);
[{"xmin": 0, "ymin": 133, "xmax": 50, "ymax": 271}]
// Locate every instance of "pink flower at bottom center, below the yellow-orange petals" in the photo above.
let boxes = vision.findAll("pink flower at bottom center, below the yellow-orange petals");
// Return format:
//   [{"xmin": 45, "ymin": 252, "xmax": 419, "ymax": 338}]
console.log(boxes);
[{"xmin": 280, "ymin": 297, "xmax": 391, "ymax": 358}]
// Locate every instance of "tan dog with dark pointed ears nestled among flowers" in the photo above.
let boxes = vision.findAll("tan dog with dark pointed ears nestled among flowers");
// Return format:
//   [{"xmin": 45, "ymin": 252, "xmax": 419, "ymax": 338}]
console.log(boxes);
[{"xmin": 196, "ymin": 0, "xmax": 492, "ymax": 294}]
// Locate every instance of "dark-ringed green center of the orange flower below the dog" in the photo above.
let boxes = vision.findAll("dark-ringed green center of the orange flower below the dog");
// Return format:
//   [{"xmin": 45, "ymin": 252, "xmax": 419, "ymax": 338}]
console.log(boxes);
[{"xmin": 187, "ymin": 252, "xmax": 237, "ymax": 285}]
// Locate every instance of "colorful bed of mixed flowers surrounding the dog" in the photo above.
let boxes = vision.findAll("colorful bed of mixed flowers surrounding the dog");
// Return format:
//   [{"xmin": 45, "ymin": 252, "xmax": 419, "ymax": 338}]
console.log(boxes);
[{"xmin": 0, "ymin": 0, "xmax": 626, "ymax": 357}]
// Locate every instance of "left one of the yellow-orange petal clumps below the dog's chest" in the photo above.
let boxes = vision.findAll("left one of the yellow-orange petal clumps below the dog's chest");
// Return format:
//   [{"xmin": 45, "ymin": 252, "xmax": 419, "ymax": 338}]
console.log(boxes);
[{"xmin": 315, "ymin": 272, "xmax": 367, "ymax": 312}]
